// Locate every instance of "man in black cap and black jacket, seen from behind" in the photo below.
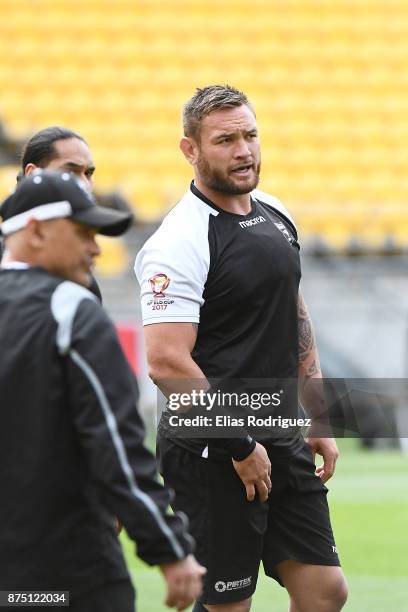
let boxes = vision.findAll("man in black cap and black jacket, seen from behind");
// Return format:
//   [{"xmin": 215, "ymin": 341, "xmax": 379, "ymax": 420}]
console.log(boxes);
[{"xmin": 0, "ymin": 171, "xmax": 204, "ymax": 612}]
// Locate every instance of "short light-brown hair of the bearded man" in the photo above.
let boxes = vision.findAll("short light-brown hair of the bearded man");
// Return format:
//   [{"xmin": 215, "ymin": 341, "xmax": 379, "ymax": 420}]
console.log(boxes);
[{"xmin": 183, "ymin": 85, "xmax": 255, "ymax": 137}]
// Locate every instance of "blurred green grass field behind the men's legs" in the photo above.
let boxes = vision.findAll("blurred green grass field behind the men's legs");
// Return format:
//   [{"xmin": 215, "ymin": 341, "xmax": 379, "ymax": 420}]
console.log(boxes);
[{"xmin": 122, "ymin": 440, "xmax": 408, "ymax": 612}]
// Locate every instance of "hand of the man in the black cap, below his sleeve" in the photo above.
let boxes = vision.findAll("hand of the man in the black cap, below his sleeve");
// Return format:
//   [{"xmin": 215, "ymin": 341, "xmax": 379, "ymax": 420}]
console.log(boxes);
[{"xmin": 160, "ymin": 555, "xmax": 207, "ymax": 610}]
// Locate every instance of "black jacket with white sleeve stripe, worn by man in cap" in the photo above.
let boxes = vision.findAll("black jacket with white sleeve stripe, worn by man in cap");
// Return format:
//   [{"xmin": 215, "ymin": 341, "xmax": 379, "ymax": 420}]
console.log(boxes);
[{"xmin": 0, "ymin": 268, "xmax": 191, "ymax": 596}]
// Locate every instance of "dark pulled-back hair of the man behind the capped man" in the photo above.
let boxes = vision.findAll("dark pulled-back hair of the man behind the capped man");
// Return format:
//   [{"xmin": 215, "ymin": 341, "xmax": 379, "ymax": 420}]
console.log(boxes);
[{"xmin": 17, "ymin": 126, "xmax": 85, "ymax": 180}]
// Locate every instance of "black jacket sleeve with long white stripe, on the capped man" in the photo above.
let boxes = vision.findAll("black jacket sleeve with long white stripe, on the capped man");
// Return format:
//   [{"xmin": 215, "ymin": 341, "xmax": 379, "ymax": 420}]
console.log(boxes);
[{"xmin": 64, "ymin": 300, "xmax": 192, "ymax": 565}]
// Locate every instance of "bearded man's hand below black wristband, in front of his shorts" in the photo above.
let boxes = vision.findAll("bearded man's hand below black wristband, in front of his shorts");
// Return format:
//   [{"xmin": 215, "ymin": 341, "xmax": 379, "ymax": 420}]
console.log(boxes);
[{"xmin": 232, "ymin": 442, "xmax": 272, "ymax": 502}]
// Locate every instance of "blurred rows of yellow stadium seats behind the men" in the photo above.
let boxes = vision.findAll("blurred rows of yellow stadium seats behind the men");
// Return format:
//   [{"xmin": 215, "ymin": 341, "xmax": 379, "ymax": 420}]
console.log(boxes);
[{"xmin": 0, "ymin": 0, "xmax": 408, "ymax": 250}]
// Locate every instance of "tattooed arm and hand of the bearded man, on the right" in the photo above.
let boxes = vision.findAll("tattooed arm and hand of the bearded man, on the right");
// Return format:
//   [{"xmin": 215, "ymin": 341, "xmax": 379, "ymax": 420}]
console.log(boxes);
[{"xmin": 298, "ymin": 289, "xmax": 339, "ymax": 482}]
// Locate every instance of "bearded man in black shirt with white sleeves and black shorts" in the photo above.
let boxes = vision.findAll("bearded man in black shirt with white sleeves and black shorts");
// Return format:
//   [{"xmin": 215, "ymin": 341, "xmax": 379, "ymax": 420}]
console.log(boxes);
[{"xmin": 135, "ymin": 86, "xmax": 346, "ymax": 612}]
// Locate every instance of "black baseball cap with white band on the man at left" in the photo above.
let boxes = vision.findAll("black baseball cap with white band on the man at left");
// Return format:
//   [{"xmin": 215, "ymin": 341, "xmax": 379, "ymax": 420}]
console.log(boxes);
[{"xmin": 0, "ymin": 169, "xmax": 133, "ymax": 236}]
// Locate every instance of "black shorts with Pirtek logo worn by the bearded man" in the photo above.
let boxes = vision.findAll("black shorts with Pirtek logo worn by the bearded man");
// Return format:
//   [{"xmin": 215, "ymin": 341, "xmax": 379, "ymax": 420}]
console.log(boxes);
[{"xmin": 158, "ymin": 437, "xmax": 340, "ymax": 604}]
